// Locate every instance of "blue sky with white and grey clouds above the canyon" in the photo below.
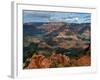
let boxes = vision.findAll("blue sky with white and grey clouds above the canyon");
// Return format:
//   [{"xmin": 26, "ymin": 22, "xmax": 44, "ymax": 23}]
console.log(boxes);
[{"xmin": 23, "ymin": 10, "xmax": 91, "ymax": 23}]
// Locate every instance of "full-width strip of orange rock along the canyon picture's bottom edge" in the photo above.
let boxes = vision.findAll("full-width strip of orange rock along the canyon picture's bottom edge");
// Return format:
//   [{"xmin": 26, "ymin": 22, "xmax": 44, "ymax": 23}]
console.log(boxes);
[{"xmin": 23, "ymin": 53, "xmax": 91, "ymax": 69}]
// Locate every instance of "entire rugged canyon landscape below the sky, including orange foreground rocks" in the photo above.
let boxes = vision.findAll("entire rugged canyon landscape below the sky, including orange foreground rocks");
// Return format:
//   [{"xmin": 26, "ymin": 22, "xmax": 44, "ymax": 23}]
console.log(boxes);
[{"xmin": 23, "ymin": 21, "xmax": 91, "ymax": 69}]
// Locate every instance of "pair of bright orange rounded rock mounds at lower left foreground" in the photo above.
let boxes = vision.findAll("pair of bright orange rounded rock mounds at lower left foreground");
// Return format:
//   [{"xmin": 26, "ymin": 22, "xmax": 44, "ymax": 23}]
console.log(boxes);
[{"xmin": 26, "ymin": 54, "xmax": 70, "ymax": 69}]
